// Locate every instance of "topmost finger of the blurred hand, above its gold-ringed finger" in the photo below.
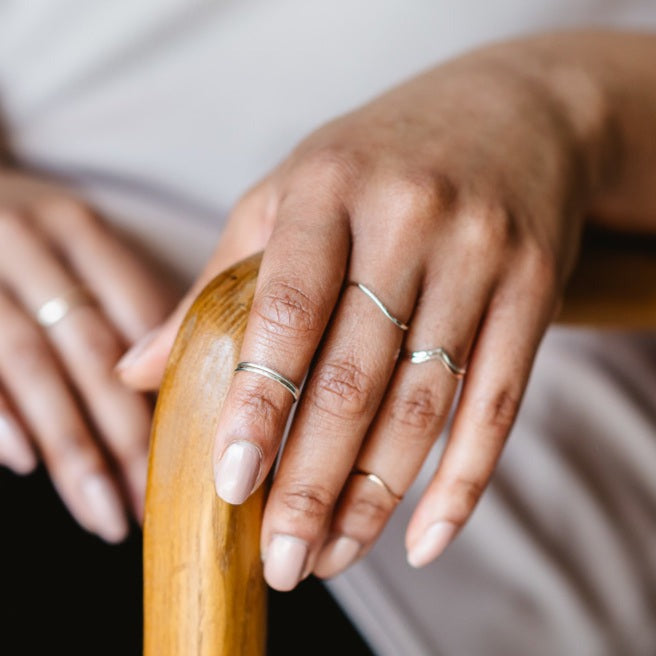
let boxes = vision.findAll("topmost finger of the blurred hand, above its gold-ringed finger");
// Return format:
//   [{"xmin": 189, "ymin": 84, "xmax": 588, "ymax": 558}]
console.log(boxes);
[{"xmin": 32, "ymin": 196, "xmax": 174, "ymax": 344}]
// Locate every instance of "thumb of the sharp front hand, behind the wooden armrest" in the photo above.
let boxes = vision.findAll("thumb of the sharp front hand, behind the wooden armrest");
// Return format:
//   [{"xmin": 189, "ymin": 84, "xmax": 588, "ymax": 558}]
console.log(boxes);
[{"xmin": 116, "ymin": 184, "xmax": 273, "ymax": 391}]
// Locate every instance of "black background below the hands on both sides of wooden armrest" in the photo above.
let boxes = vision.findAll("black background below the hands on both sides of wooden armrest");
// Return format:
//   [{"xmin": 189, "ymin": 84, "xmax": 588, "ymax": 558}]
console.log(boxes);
[{"xmin": 0, "ymin": 468, "xmax": 371, "ymax": 656}]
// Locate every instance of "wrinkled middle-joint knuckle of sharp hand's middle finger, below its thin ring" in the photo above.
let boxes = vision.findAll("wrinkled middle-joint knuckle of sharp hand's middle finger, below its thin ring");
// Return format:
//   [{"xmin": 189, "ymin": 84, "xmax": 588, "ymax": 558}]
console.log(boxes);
[{"xmin": 309, "ymin": 360, "xmax": 373, "ymax": 417}]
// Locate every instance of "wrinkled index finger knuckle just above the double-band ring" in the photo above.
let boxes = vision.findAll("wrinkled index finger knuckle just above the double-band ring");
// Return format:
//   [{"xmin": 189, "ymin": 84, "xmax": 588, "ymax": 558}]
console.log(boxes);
[{"xmin": 252, "ymin": 281, "xmax": 320, "ymax": 338}]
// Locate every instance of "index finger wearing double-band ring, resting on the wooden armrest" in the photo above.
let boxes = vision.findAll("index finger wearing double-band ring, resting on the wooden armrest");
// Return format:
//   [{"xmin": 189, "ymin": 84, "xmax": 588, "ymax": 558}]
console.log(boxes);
[{"xmin": 214, "ymin": 193, "xmax": 350, "ymax": 503}]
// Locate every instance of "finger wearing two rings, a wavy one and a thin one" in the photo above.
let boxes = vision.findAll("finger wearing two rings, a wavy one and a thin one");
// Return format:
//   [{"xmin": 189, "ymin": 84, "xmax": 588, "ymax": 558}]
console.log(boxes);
[{"xmin": 314, "ymin": 262, "xmax": 492, "ymax": 577}]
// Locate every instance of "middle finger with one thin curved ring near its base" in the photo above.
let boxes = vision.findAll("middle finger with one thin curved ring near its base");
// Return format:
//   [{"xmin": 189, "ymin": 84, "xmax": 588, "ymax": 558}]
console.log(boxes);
[{"xmin": 262, "ymin": 255, "xmax": 417, "ymax": 590}]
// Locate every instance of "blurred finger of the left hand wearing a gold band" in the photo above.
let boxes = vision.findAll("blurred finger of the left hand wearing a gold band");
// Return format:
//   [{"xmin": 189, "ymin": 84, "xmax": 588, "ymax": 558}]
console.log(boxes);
[{"xmin": 0, "ymin": 215, "xmax": 150, "ymax": 517}]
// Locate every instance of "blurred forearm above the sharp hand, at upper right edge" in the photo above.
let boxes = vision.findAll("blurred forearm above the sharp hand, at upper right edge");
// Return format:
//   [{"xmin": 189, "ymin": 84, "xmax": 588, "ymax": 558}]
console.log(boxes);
[{"xmin": 476, "ymin": 31, "xmax": 656, "ymax": 232}]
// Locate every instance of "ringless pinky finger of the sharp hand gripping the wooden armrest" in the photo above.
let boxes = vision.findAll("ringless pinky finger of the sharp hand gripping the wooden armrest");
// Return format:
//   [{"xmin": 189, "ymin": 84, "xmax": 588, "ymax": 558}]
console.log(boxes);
[{"xmin": 406, "ymin": 270, "xmax": 555, "ymax": 567}]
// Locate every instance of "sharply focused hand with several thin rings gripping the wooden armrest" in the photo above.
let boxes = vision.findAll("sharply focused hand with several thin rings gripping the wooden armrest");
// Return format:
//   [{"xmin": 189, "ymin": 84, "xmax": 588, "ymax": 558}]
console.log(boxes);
[{"xmin": 122, "ymin": 43, "xmax": 603, "ymax": 590}]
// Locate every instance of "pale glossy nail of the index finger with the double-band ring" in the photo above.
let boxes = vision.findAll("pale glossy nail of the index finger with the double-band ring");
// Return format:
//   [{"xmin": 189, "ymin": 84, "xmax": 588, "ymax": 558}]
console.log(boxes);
[{"xmin": 214, "ymin": 442, "xmax": 262, "ymax": 504}]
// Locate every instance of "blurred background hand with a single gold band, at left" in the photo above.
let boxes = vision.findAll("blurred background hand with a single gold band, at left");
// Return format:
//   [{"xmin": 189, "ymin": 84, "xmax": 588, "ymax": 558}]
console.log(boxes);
[{"xmin": 0, "ymin": 172, "xmax": 179, "ymax": 542}]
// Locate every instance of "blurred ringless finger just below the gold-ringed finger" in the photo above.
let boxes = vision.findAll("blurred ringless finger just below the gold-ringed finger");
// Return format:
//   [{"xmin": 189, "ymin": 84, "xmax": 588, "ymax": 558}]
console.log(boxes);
[{"xmin": 0, "ymin": 294, "xmax": 128, "ymax": 542}]
